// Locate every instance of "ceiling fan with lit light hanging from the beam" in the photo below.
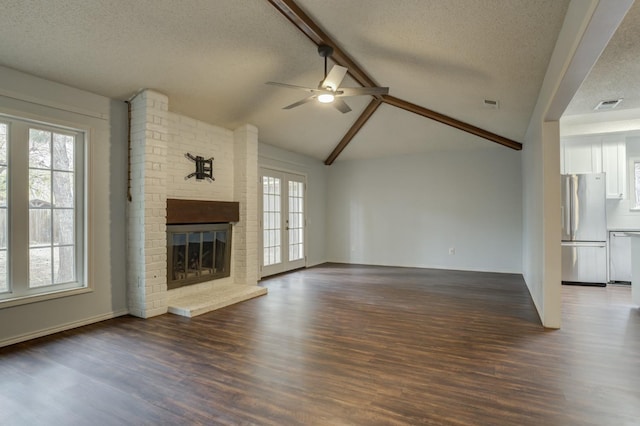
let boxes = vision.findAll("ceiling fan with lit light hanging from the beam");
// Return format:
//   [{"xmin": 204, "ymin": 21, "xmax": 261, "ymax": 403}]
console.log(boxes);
[{"xmin": 266, "ymin": 44, "xmax": 389, "ymax": 114}]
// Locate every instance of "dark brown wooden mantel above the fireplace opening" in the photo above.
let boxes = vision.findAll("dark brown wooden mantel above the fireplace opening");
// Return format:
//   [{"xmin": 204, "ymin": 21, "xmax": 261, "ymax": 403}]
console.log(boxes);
[{"xmin": 167, "ymin": 198, "xmax": 240, "ymax": 225}]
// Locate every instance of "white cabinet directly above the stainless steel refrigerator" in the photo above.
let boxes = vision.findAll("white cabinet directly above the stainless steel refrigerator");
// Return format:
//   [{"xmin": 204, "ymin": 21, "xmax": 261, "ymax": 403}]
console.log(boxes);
[{"xmin": 560, "ymin": 137, "xmax": 603, "ymax": 174}]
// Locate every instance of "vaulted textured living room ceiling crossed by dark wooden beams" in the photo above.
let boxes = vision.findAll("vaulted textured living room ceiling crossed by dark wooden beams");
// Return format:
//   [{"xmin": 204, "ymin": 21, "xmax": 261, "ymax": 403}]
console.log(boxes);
[{"xmin": 0, "ymin": 0, "xmax": 568, "ymax": 160}]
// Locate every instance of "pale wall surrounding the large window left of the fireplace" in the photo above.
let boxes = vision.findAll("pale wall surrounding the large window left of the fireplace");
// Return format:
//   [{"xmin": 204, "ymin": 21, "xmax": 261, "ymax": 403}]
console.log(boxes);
[{"xmin": 0, "ymin": 67, "xmax": 128, "ymax": 346}]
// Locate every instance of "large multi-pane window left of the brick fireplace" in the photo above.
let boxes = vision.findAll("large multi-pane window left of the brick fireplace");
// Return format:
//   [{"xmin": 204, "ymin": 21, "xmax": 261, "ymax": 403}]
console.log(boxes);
[{"xmin": 0, "ymin": 116, "xmax": 86, "ymax": 302}]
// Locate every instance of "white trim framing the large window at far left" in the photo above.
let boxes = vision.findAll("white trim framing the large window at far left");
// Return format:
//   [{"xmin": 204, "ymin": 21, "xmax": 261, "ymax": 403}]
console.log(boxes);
[{"xmin": 0, "ymin": 111, "xmax": 94, "ymax": 309}]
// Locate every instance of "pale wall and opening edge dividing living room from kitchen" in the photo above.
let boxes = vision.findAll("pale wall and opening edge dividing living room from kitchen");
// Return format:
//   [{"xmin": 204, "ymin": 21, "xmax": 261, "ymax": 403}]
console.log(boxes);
[{"xmin": 522, "ymin": 0, "xmax": 598, "ymax": 328}]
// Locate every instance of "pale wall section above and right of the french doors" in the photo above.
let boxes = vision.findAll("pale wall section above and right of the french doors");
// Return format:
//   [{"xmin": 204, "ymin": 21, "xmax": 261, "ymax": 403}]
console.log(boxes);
[{"xmin": 258, "ymin": 143, "xmax": 330, "ymax": 266}]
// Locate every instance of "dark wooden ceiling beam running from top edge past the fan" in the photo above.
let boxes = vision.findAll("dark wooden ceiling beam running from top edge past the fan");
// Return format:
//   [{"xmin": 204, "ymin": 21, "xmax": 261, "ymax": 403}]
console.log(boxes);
[{"xmin": 268, "ymin": 0, "xmax": 378, "ymax": 87}]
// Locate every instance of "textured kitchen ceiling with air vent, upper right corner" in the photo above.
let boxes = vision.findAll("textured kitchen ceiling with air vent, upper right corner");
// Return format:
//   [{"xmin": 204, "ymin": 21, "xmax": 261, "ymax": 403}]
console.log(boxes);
[{"xmin": 565, "ymin": 1, "xmax": 640, "ymax": 119}]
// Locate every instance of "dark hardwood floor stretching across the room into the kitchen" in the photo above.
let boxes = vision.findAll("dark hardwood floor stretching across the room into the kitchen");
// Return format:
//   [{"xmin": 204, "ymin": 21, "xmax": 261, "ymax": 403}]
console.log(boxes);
[{"xmin": 0, "ymin": 265, "xmax": 640, "ymax": 425}]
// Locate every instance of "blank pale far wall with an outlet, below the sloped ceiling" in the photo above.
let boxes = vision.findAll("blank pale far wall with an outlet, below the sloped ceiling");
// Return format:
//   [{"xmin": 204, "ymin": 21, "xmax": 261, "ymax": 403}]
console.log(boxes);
[{"xmin": 326, "ymin": 147, "xmax": 522, "ymax": 273}]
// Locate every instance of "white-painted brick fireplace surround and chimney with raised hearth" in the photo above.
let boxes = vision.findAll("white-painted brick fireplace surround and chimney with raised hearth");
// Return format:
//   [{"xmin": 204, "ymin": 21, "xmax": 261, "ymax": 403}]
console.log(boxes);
[{"xmin": 127, "ymin": 90, "xmax": 266, "ymax": 318}]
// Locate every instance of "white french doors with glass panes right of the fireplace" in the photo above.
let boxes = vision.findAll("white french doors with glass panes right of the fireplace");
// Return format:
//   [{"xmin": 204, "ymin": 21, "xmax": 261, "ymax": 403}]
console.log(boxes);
[{"xmin": 260, "ymin": 169, "xmax": 306, "ymax": 277}]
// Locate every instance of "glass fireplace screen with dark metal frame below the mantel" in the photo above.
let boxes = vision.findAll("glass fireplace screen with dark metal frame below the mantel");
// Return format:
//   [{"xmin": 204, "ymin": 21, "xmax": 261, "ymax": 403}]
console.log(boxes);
[{"xmin": 167, "ymin": 223, "xmax": 231, "ymax": 289}]
